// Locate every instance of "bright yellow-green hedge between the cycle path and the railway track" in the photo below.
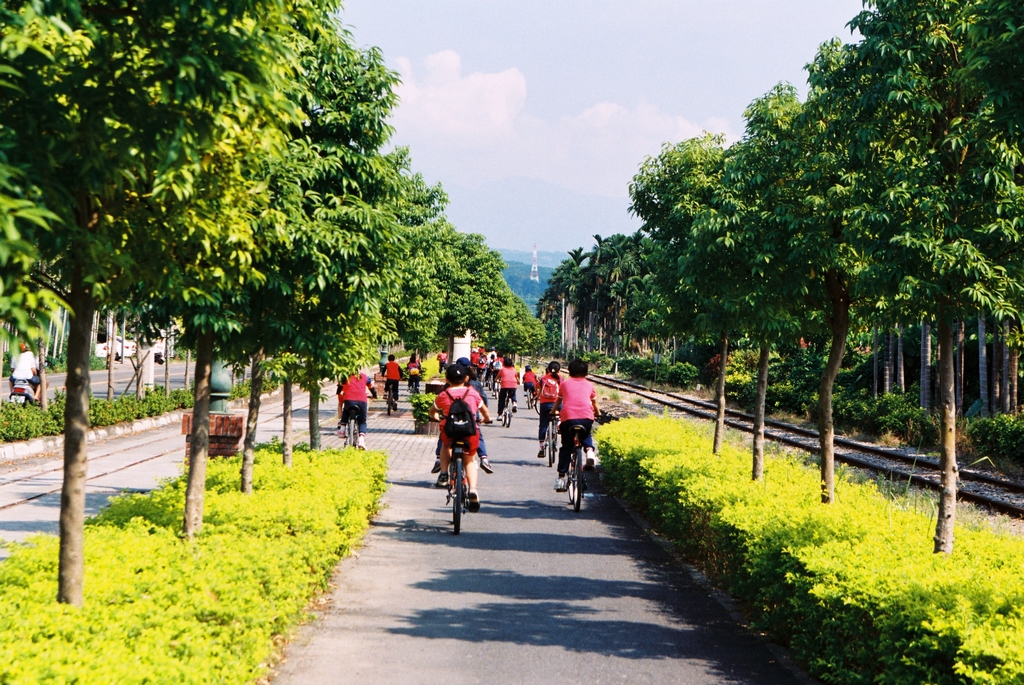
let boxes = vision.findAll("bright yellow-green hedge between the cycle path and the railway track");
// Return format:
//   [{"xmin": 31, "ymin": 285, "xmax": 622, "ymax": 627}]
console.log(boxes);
[{"xmin": 599, "ymin": 419, "xmax": 1024, "ymax": 685}]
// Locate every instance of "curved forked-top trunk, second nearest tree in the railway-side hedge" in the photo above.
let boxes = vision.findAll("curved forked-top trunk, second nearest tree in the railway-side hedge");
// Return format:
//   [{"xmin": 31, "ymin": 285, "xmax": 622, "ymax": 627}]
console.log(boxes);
[{"xmin": 818, "ymin": 269, "xmax": 847, "ymax": 504}]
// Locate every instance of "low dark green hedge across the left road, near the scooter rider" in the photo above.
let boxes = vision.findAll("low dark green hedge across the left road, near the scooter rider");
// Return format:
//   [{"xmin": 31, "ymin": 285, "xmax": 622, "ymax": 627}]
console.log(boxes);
[{"xmin": 0, "ymin": 387, "xmax": 193, "ymax": 442}]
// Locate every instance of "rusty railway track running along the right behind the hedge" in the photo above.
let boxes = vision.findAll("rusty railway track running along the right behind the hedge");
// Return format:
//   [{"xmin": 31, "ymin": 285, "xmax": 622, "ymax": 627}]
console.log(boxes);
[{"xmin": 590, "ymin": 374, "xmax": 1024, "ymax": 518}]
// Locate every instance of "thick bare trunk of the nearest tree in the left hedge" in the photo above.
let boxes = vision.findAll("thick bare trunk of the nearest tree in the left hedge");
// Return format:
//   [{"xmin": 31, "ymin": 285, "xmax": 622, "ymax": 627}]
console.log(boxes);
[{"xmin": 57, "ymin": 265, "xmax": 95, "ymax": 606}]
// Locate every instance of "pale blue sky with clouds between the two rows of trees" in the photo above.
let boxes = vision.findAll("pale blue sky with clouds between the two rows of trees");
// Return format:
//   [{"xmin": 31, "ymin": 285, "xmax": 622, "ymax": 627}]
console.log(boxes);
[{"xmin": 342, "ymin": 0, "xmax": 861, "ymax": 251}]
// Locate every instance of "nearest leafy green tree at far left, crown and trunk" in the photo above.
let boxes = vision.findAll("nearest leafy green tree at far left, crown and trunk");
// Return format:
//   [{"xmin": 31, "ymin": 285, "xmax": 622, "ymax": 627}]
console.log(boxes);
[{"xmin": 0, "ymin": 0, "xmax": 311, "ymax": 604}]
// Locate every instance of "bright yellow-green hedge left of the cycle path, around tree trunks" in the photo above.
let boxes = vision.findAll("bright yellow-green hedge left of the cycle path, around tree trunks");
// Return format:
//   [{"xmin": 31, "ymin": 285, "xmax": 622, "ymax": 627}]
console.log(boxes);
[{"xmin": 0, "ymin": 446, "xmax": 386, "ymax": 685}]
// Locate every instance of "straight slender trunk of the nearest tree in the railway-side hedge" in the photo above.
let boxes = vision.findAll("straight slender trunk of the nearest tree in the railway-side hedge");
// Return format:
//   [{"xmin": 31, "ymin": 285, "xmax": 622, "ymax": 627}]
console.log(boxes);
[{"xmin": 935, "ymin": 312, "xmax": 958, "ymax": 554}]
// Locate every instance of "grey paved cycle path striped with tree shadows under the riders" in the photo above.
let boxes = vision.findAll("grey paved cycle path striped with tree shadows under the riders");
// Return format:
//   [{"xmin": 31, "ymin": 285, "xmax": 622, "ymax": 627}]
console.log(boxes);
[{"xmin": 275, "ymin": 393, "xmax": 796, "ymax": 685}]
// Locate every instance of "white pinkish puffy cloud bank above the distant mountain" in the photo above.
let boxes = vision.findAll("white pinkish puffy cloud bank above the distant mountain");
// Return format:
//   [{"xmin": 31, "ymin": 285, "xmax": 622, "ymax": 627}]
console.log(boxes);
[{"xmin": 392, "ymin": 50, "xmax": 734, "ymax": 198}]
